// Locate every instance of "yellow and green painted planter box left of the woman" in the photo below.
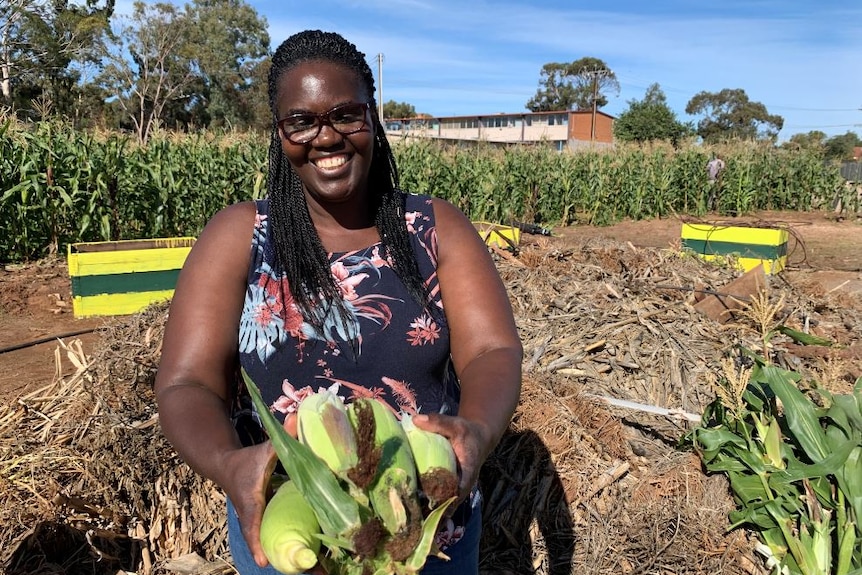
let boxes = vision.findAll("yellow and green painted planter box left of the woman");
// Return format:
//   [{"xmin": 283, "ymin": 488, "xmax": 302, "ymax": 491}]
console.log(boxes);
[{"xmin": 68, "ymin": 238, "xmax": 195, "ymax": 317}]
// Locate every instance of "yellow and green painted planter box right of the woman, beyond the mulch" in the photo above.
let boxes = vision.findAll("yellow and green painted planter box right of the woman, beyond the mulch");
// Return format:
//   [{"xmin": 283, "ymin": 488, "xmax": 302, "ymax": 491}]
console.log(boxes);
[{"xmin": 682, "ymin": 223, "xmax": 788, "ymax": 274}]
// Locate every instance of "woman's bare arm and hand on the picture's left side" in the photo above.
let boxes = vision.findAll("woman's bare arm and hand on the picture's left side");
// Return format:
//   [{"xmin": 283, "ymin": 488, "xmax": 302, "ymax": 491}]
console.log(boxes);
[{"xmin": 155, "ymin": 202, "xmax": 275, "ymax": 564}]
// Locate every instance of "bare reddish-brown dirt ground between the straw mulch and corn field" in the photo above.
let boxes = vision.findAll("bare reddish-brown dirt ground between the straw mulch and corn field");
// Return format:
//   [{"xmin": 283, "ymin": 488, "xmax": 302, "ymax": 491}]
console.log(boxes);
[{"xmin": 0, "ymin": 212, "xmax": 862, "ymax": 402}]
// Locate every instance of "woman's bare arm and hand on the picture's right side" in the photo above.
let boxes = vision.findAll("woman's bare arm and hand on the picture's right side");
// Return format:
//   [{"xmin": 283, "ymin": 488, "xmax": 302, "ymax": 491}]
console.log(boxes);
[{"xmin": 414, "ymin": 199, "xmax": 523, "ymax": 502}]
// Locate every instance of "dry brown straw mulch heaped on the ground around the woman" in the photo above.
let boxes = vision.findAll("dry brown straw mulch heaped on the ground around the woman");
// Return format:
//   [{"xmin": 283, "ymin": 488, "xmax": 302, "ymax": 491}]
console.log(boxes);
[{"xmin": 0, "ymin": 238, "xmax": 862, "ymax": 575}]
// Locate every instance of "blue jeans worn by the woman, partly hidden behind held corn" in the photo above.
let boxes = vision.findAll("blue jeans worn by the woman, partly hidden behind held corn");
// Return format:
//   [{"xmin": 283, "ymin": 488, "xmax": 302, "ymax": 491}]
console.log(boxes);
[{"xmin": 227, "ymin": 499, "xmax": 482, "ymax": 575}]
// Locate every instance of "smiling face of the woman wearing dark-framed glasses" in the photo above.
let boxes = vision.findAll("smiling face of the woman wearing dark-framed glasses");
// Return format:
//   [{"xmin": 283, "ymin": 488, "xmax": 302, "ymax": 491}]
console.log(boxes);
[{"xmin": 276, "ymin": 60, "xmax": 374, "ymax": 209}]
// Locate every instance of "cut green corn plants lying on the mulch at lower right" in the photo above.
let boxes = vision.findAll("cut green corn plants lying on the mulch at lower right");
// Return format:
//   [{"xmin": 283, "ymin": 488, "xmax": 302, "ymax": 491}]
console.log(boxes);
[{"xmin": 691, "ymin": 363, "xmax": 862, "ymax": 575}]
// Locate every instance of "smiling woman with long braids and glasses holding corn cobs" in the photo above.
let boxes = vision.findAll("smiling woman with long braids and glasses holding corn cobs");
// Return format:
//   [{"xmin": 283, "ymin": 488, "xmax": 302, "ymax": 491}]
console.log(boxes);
[{"xmin": 156, "ymin": 31, "xmax": 522, "ymax": 574}]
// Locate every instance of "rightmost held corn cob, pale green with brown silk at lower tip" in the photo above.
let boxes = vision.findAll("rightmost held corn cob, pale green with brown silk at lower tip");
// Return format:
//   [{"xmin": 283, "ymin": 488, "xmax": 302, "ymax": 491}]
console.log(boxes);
[{"xmin": 401, "ymin": 413, "xmax": 458, "ymax": 509}]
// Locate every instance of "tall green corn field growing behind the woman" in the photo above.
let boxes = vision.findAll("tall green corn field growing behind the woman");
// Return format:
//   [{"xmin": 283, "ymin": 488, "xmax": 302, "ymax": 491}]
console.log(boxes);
[{"xmin": 0, "ymin": 118, "xmax": 862, "ymax": 262}]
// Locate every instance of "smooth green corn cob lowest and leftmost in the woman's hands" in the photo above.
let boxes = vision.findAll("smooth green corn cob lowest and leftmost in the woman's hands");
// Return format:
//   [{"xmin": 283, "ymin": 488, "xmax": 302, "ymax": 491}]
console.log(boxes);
[{"xmin": 260, "ymin": 480, "xmax": 320, "ymax": 575}]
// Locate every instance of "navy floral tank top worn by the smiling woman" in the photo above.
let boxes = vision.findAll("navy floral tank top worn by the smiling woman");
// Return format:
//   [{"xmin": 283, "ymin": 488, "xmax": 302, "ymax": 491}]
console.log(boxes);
[{"xmin": 233, "ymin": 194, "xmax": 478, "ymax": 548}]
